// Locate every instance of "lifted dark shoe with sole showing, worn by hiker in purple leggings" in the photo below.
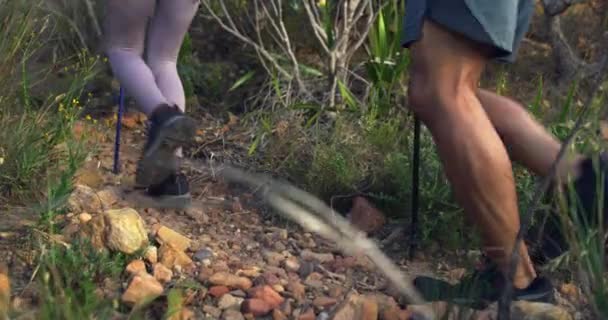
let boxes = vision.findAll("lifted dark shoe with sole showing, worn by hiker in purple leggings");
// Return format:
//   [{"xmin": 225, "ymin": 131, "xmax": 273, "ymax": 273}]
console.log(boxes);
[{"xmin": 135, "ymin": 105, "xmax": 196, "ymax": 188}]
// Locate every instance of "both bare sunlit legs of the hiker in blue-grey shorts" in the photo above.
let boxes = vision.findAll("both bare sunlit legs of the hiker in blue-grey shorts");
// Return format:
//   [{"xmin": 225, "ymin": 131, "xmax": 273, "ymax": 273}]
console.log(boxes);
[{"xmin": 409, "ymin": 20, "xmax": 580, "ymax": 288}]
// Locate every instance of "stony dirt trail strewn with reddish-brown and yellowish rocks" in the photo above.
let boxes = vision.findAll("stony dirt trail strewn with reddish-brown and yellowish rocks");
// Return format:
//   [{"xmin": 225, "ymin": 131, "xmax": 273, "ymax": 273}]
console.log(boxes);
[{"xmin": 0, "ymin": 109, "xmax": 585, "ymax": 320}]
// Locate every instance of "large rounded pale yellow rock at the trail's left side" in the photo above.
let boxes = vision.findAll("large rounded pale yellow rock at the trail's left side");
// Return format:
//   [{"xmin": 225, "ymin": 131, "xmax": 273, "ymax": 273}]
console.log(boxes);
[{"xmin": 104, "ymin": 208, "xmax": 148, "ymax": 254}]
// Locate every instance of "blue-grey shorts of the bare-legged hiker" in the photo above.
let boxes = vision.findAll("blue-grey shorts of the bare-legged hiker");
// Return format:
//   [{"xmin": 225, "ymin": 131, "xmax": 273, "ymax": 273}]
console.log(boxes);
[{"xmin": 402, "ymin": 0, "xmax": 534, "ymax": 62}]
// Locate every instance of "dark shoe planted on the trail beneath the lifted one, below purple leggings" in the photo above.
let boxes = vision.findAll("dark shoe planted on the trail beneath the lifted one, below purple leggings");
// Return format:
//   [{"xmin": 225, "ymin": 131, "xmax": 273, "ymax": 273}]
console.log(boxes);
[{"xmin": 146, "ymin": 173, "xmax": 191, "ymax": 209}]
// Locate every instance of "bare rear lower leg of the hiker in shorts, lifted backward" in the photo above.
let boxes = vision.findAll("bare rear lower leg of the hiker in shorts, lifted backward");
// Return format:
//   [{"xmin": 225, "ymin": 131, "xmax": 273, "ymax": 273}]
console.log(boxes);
[{"xmin": 477, "ymin": 89, "xmax": 583, "ymax": 181}]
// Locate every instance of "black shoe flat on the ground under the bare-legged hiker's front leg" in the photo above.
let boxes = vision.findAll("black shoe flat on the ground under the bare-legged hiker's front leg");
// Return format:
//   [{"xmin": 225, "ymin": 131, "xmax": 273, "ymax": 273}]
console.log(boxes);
[{"xmin": 414, "ymin": 266, "xmax": 553, "ymax": 310}]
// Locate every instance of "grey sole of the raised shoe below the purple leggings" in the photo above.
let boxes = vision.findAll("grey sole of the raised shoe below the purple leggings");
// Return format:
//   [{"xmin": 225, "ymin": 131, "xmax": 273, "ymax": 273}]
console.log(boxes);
[{"xmin": 135, "ymin": 116, "xmax": 196, "ymax": 188}]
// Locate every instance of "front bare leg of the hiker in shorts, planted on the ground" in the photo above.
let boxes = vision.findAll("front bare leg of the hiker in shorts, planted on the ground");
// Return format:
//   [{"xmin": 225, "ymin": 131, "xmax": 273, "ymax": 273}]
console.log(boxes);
[{"xmin": 409, "ymin": 20, "xmax": 536, "ymax": 288}]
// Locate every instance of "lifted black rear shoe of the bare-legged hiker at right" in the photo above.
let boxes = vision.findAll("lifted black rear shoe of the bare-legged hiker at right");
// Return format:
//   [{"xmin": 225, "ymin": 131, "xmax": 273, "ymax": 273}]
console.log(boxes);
[{"xmin": 527, "ymin": 153, "xmax": 608, "ymax": 264}]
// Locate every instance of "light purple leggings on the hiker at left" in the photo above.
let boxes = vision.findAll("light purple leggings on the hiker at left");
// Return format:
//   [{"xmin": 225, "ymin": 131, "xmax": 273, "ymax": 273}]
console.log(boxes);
[{"xmin": 104, "ymin": 0, "xmax": 200, "ymax": 115}]
